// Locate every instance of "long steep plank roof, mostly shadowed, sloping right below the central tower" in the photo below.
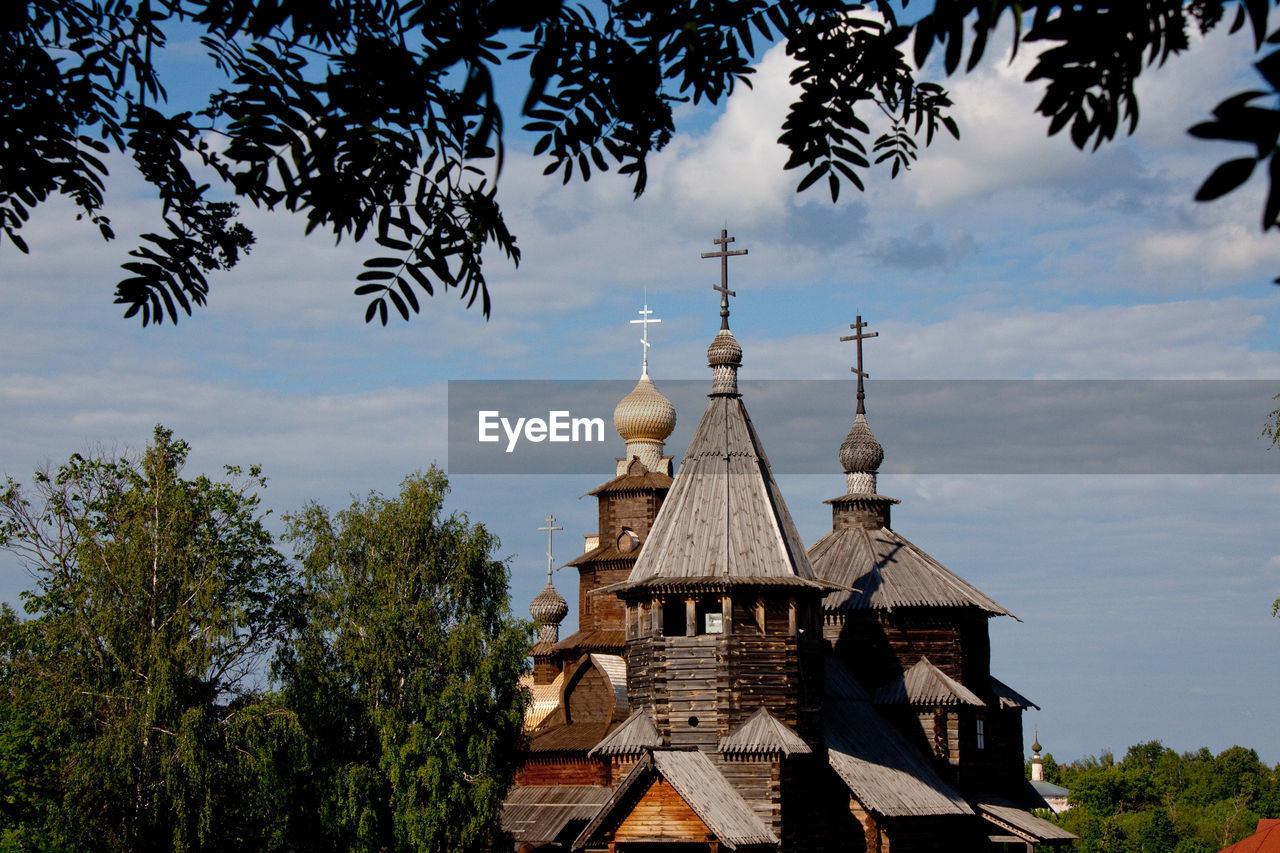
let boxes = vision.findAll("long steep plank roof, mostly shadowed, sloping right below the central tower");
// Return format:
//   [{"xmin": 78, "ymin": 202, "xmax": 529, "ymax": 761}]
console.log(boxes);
[{"xmin": 822, "ymin": 654, "xmax": 974, "ymax": 817}]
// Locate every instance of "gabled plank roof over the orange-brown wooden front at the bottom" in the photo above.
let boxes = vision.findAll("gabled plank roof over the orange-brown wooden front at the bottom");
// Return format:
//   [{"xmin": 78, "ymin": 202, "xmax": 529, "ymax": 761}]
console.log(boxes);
[{"xmin": 572, "ymin": 749, "xmax": 778, "ymax": 850}]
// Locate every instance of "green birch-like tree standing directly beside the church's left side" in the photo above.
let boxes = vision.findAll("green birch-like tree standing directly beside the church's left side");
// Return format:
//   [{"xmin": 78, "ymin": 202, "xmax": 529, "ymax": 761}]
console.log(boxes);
[{"xmin": 275, "ymin": 469, "xmax": 530, "ymax": 853}]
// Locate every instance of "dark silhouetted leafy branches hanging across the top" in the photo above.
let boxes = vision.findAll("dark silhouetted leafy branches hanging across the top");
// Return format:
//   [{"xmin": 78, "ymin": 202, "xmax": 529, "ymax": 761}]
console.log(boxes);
[{"xmin": 10, "ymin": 0, "xmax": 1280, "ymax": 324}]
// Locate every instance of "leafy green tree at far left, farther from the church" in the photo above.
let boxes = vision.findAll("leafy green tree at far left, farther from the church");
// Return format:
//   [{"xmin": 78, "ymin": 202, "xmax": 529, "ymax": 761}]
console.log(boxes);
[{"xmin": 0, "ymin": 427, "xmax": 301, "ymax": 850}]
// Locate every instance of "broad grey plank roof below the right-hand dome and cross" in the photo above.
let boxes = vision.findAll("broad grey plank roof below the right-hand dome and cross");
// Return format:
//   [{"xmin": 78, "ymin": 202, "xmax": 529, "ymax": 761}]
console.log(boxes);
[{"xmin": 809, "ymin": 526, "xmax": 1021, "ymax": 621}]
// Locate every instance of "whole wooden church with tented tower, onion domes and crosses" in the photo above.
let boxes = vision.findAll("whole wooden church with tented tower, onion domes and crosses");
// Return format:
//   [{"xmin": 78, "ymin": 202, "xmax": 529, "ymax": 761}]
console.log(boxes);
[{"xmin": 502, "ymin": 232, "xmax": 1074, "ymax": 853}]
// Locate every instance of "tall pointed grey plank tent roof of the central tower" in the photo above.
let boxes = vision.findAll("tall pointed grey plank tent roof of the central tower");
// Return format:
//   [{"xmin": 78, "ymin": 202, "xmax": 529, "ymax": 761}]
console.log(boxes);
[{"xmin": 623, "ymin": 396, "xmax": 820, "ymax": 589}]
